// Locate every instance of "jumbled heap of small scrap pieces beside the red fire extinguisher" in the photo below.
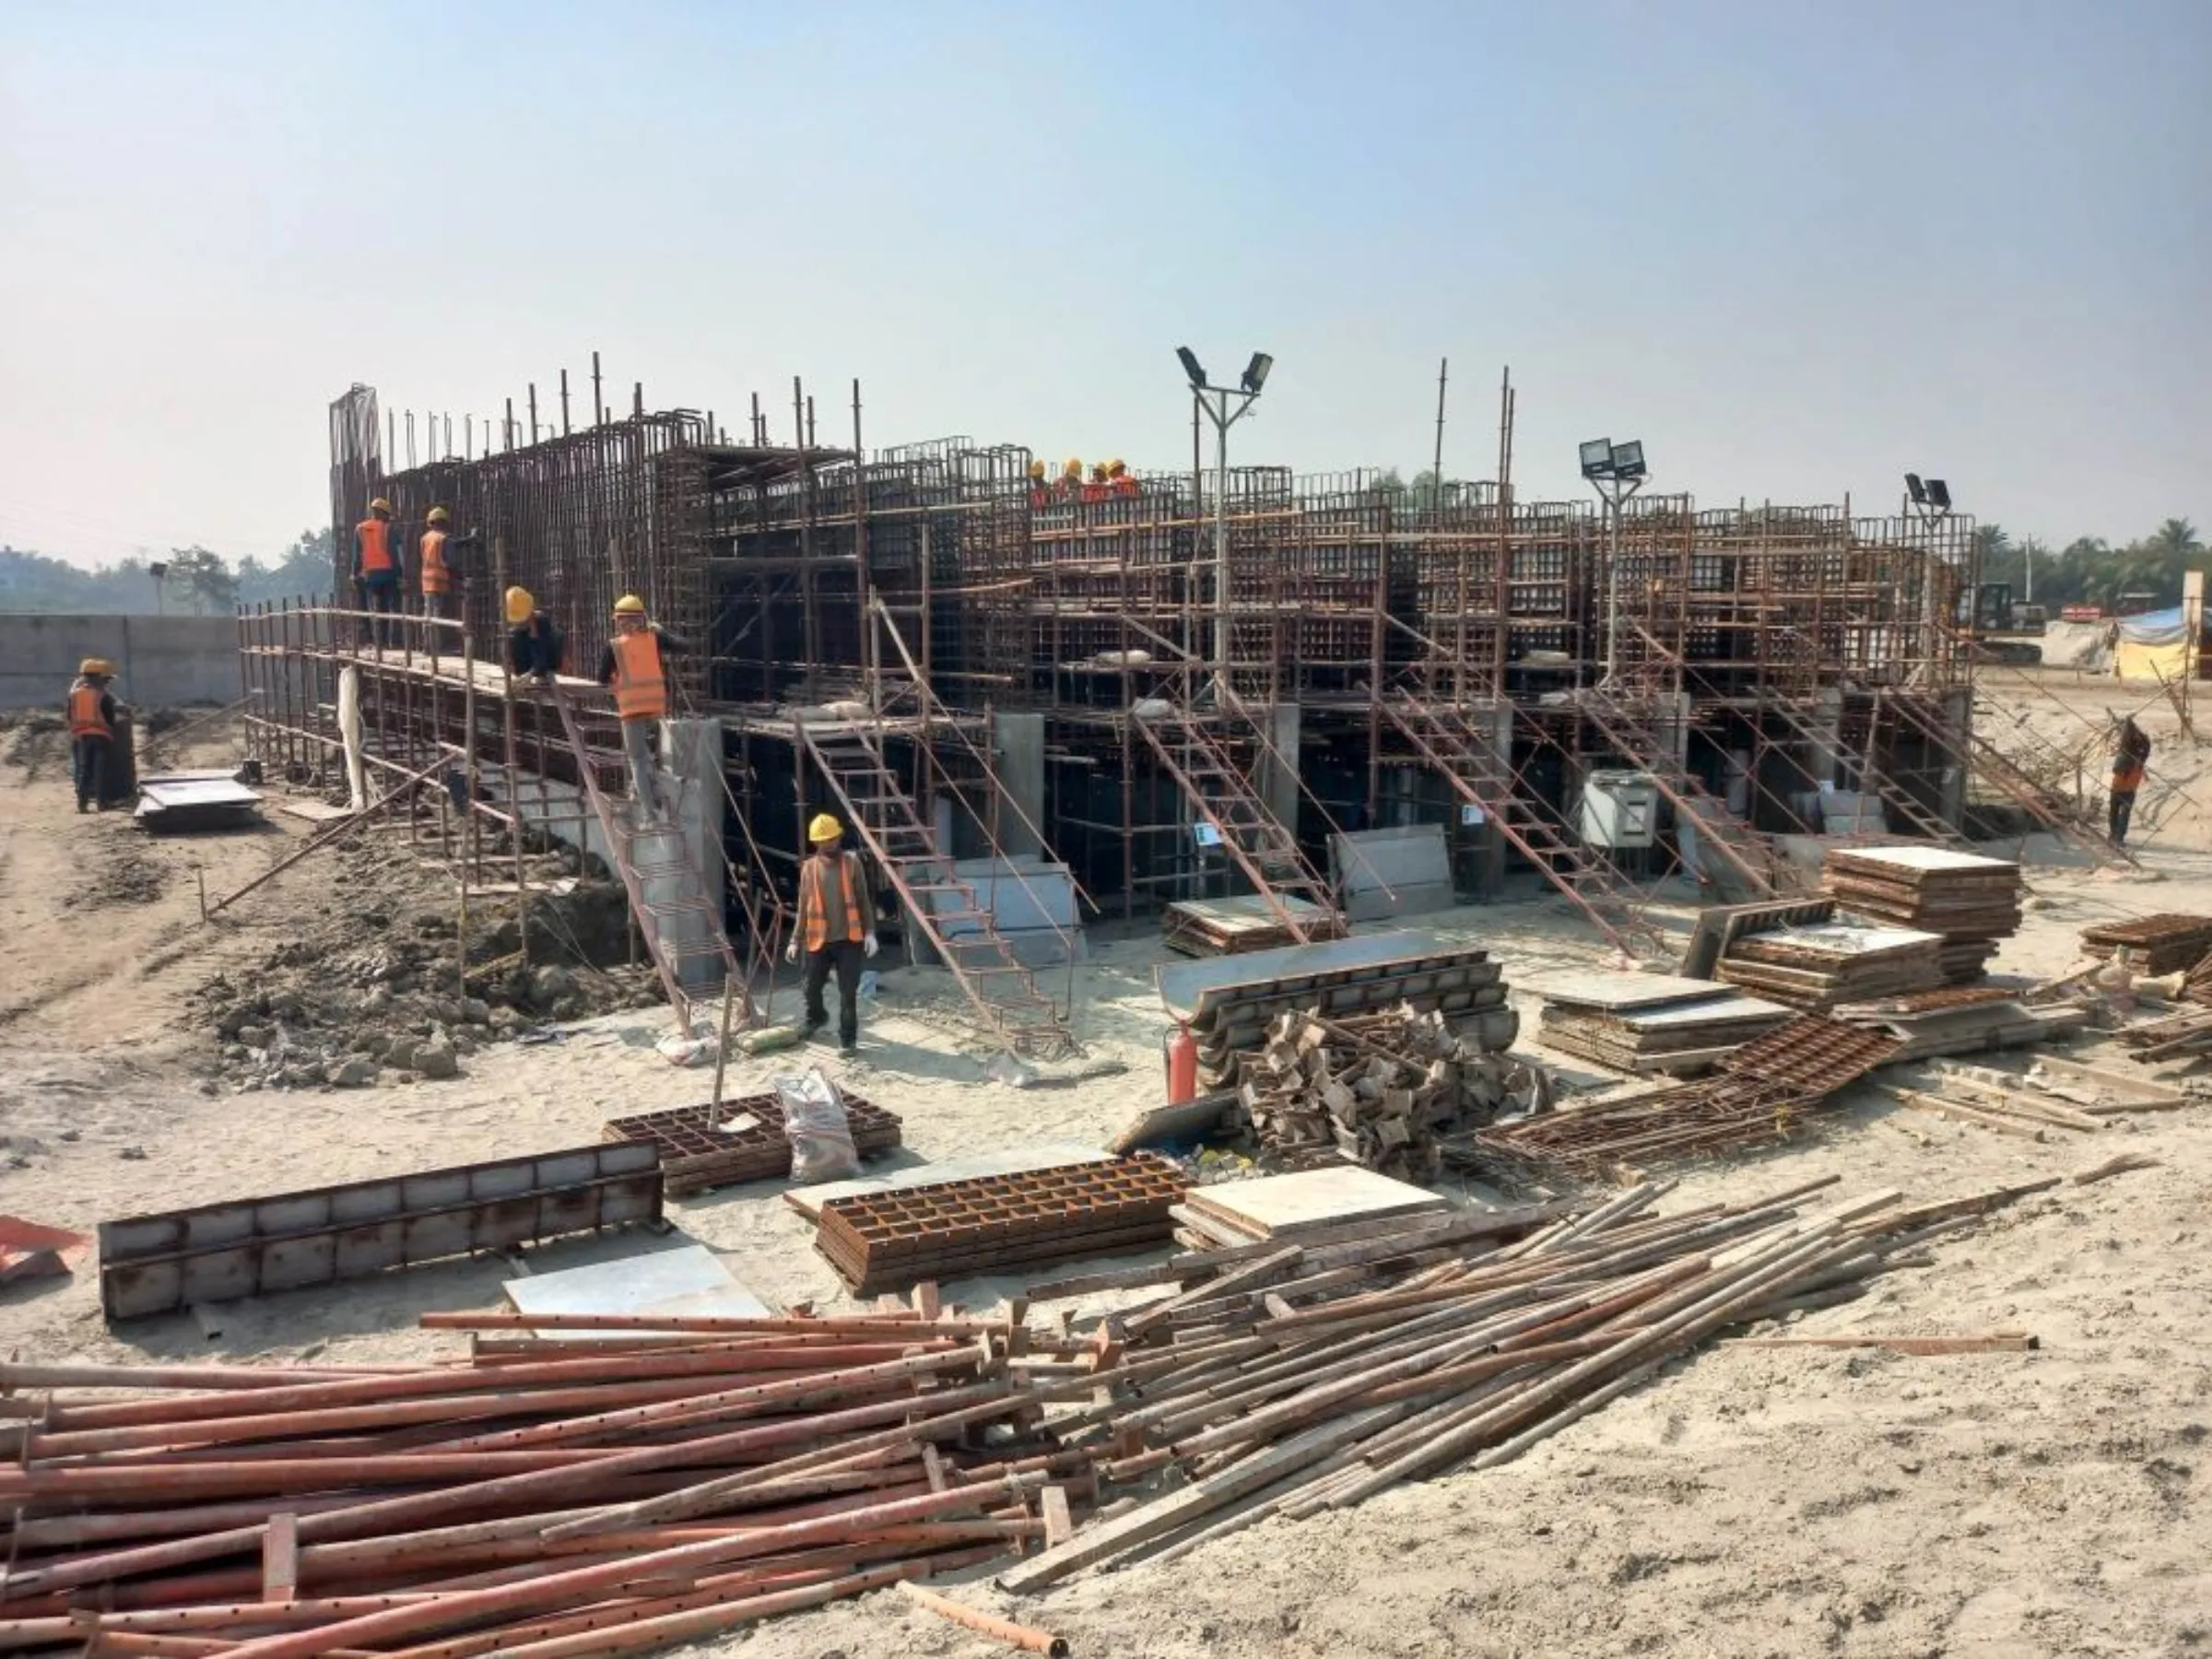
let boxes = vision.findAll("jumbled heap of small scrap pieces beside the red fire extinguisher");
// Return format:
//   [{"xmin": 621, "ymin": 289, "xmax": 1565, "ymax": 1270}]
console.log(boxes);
[{"xmin": 1226, "ymin": 1006, "xmax": 1550, "ymax": 1182}]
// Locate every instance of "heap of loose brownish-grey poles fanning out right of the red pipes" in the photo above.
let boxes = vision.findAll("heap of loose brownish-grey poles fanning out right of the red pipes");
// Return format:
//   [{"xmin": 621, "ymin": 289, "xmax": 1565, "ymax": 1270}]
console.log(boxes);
[{"xmin": 997, "ymin": 1177, "xmax": 2055, "ymax": 1593}]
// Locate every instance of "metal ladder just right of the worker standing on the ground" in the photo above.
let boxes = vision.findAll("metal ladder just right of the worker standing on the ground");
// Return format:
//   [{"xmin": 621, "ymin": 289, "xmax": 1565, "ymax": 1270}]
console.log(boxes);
[{"xmin": 796, "ymin": 721, "xmax": 1079, "ymax": 1060}]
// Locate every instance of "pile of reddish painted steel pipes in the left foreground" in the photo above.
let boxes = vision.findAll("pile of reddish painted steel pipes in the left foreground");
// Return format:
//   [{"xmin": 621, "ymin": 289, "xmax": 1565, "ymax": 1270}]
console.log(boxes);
[{"xmin": 0, "ymin": 1305, "xmax": 1084, "ymax": 1659}]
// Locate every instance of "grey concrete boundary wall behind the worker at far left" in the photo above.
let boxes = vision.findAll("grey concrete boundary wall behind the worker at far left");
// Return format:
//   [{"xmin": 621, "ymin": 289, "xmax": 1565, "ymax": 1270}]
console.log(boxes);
[{"xmin": 0, "ymin": 615, "xmax": 241, "ymax": 708}]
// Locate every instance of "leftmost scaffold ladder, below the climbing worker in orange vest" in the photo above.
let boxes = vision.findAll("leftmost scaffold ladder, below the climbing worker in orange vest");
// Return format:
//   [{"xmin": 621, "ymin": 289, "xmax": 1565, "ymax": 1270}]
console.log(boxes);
[{"xmin": 553, "ymin": 690, "xmax": 774, "ymax": 1035}]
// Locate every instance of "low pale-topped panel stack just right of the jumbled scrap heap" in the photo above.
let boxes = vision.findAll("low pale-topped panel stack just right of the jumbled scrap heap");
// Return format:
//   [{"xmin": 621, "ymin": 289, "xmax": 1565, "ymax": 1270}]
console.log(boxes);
[{"xmin": 1528, "ymin": 973, "xmax": 1790, "ymax": 1077}]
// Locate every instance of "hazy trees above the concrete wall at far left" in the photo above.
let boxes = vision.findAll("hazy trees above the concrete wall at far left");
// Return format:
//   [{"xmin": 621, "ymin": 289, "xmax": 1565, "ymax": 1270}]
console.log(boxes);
[{"xmin": 0, "ymin": 529, "xmax": 332, "ymax": 618}]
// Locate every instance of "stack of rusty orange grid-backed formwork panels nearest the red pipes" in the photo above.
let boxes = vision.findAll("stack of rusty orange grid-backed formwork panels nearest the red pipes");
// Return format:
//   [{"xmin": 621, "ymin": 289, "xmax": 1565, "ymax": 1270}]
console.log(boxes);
[{"xmin": 814, "ymin": 1152, "xmax": 1190, "ymax": 1296}]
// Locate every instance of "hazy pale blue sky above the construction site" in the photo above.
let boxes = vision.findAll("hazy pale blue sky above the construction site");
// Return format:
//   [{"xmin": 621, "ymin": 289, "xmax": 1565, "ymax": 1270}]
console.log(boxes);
[{"xmin": 0, "ymin": 0, "xmax": 2212, "ymax": 562}]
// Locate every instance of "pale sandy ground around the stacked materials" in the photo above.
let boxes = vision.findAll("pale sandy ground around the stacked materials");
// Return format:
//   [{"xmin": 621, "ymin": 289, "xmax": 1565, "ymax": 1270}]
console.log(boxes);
[{"xmin": 0, "ymin": 708, "xmax": 2212, "ymax": 1659}]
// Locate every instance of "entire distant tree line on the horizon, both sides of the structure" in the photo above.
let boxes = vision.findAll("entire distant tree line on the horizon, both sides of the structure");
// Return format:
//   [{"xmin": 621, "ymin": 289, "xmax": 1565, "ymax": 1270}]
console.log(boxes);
[{"xmin": 0, "ymin": 512, "xmax": 2206, "ymax": 618}]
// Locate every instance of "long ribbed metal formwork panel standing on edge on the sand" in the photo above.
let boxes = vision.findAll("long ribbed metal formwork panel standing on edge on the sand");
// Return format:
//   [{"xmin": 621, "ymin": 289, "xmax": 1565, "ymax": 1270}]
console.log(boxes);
[{"xmin": 100, "ymin": 1141, "xmax": 662, "ymax": 1318}]
